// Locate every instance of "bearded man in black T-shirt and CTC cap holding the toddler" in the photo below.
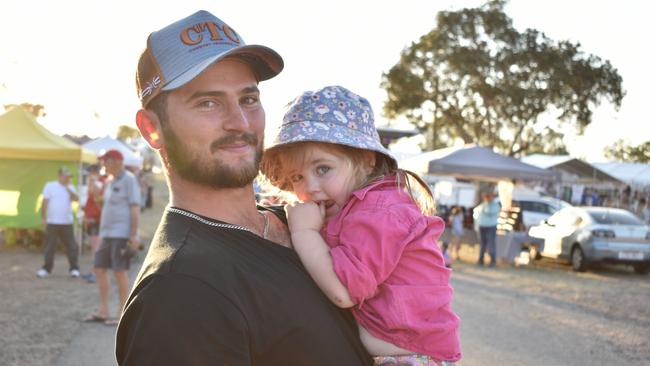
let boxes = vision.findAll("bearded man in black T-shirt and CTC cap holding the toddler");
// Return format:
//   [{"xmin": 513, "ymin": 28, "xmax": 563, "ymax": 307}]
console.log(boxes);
[{"xmin": 116, "ymin": 11, "xmax": 372, "ymax": 366}]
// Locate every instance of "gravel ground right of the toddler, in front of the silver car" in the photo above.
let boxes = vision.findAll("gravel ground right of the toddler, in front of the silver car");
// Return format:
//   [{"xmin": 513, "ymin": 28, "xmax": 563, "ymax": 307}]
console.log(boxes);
[{"xmin": 452, "ymin": 254, "xmax": 650, "ymax": 366}]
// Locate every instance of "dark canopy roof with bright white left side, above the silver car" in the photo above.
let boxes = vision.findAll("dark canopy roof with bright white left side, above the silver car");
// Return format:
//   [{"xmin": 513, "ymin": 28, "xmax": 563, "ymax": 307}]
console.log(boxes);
[{"xmin": 521, "ymin": 154, "xmax": 622, "ymax": 183}]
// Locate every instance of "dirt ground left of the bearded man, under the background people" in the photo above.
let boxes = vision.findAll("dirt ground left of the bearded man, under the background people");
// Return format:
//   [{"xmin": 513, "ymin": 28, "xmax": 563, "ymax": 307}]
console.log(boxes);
[{"xmin": 0, "ymin": 176, "xmax": 168, "ymax": 366}]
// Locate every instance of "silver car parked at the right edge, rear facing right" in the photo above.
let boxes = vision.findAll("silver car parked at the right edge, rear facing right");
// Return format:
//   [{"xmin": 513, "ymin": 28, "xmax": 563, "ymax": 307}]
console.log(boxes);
[{"xmin": 528, "ymin": 207, "xmax": 650, "ymax": 274}]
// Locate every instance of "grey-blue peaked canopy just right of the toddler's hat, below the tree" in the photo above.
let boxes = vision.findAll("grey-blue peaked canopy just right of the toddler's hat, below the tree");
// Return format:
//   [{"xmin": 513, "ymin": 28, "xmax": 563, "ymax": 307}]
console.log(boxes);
[{"xmin": 399, "ymin": 144, "xmax": 558, "ymax": 181}]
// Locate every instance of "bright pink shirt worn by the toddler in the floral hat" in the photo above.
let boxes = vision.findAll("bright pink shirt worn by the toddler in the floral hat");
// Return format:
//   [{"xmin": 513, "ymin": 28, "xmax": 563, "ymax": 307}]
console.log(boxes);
[{"xmin": 323, "ymin": 177, "xmax": 461, "ymax": 361}]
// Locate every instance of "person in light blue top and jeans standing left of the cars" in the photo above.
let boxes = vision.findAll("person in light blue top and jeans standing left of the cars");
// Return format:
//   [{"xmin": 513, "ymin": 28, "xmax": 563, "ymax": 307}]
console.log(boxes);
[{"xmin": 474, "ymin": 192, "xmax": 501, "ymax": 267}]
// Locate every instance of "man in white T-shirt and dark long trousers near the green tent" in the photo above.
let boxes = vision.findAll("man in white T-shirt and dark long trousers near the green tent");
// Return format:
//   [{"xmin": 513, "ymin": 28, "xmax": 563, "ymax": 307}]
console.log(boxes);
[{"xmin": 36, "ymin": 166, "xmax": 79, "ymax": 278}]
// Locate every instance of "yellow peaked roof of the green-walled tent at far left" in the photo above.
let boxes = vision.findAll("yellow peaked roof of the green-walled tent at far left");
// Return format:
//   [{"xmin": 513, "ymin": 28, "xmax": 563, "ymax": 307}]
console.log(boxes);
[{"xmin": 0, "ymin": 107, "xmax": 97, "ymax": 164}]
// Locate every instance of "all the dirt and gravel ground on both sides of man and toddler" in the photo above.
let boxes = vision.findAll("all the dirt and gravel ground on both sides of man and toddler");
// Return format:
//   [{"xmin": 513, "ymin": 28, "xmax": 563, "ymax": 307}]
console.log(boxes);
[{"xmin": 0, "ymin": 173, "xmax": 650, "ymax": 366}]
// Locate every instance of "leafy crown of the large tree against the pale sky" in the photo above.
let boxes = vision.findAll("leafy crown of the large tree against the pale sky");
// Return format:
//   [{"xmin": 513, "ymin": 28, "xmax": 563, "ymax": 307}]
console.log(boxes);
[{"xmin": 381, "ymin": 0, "xmax": 624, "ymax": 156}]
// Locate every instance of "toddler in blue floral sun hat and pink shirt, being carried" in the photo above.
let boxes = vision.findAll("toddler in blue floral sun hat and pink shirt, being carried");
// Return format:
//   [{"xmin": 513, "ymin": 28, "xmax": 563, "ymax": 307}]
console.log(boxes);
[{"xmin": 261, "ymin": 86, "xmax": 461, "ymax": 365}]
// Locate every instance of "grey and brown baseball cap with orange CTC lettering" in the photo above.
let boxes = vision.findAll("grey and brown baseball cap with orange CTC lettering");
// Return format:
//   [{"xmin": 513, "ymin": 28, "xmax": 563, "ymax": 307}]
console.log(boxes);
[{"xmin": 136, "ymin": 10, "xmax": 284, "ymax": 107}]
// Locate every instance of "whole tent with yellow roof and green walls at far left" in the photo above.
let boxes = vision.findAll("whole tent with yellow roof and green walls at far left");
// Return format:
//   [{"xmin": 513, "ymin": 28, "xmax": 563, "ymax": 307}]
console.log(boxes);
[{"xmin": 0, "ymin": 107, "xmax": 97, "ymax": 228}]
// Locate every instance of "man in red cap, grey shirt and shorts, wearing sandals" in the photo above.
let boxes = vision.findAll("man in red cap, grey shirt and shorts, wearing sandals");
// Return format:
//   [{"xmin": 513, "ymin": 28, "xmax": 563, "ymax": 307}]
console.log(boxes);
[{"xmin": 85, "ymin": 150, "xmax": 140, "ymax": 325}]
